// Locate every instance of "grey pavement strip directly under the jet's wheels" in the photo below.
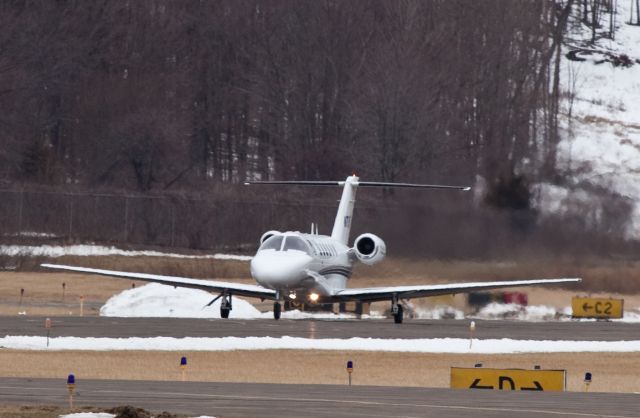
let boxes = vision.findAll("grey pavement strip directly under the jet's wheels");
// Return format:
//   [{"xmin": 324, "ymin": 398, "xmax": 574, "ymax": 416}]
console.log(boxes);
[{"xmin": 0, "ymin": 316, "xmax": 640, "ymax": 341}]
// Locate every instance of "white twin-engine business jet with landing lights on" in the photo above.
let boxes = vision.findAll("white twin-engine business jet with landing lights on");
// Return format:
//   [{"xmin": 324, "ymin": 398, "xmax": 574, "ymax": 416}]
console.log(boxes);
[{"xmin": 42, "ymin": 175, "xmax": 581, "ymax": 323}]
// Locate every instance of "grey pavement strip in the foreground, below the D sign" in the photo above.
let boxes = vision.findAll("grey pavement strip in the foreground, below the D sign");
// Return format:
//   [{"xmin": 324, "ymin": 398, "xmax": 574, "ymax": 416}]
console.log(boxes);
[{"xmin": 0, "ymin": 378, "xmax": 640, "ymax": 417}]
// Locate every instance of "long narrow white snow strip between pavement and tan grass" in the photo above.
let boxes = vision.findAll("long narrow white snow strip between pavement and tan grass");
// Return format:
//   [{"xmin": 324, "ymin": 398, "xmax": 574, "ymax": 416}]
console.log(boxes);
[{"xmin": 0, "ymin": 335, "xmax": 640, "ymax": 354}]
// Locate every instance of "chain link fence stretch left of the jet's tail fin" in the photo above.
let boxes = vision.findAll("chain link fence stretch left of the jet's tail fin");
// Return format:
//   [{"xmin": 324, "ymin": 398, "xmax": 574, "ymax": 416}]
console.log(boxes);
[{"xmin": 0, "ymin": 190, "xmax": 350, "ymax": 249}]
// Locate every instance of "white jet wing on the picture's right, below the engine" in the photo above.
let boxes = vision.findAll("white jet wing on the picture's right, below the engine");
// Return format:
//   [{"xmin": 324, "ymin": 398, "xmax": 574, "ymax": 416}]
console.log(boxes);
[{"xmin": 334, "ymin": 278, "xmax": 582, "ymax": 302}]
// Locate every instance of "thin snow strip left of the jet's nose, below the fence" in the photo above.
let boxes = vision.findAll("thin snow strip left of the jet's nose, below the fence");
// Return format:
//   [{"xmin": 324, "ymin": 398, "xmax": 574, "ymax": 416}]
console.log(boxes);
[{"xmin": 0, "ymin": 245, "xmax": 252, "ymax": 261}]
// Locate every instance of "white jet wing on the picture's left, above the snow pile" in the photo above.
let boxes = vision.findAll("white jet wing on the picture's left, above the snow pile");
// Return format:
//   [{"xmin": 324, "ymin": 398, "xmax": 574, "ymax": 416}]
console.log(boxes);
[{"xmin": 40, "ymin": 264, "xmax": 276, "ymax": 299}]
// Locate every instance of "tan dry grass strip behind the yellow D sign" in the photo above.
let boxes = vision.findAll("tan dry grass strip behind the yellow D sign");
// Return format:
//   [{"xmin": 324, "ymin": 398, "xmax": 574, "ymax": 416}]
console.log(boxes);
[{"xmin": 0, "ymin": 350, "xmax": 640, "ymax": 392}]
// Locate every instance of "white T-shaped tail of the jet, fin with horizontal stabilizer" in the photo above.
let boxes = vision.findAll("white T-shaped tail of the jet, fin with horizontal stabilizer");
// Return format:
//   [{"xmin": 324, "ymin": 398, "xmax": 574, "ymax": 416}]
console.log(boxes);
[{"xmin": 244, "ymin": 175, "xmax": 471, "ymax": 245}]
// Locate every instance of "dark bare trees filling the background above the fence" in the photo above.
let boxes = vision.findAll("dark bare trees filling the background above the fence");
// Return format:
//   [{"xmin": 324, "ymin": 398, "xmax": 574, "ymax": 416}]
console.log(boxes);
[{"xmin": 0, "ymin": 0, "xmax": 632, "ymax": 255}]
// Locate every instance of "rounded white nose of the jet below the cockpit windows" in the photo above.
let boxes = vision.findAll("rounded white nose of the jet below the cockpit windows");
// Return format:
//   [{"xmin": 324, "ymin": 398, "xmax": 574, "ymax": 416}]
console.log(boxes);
[{"xmin": 251, "ymin": 251, "xmax": 311, "ymax": 287}]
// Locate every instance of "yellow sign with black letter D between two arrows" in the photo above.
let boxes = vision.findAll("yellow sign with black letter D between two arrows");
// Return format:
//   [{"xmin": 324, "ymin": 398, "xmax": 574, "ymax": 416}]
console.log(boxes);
[{"xmin": 451, "ymin": 367, "xmax": 567, "ymax": 391}]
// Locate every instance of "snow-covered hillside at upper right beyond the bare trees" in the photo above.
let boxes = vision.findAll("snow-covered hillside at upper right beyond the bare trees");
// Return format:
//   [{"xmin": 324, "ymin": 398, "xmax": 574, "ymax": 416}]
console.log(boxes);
[{"xmin": 542, "ymin": 1, "xmax": 640, "ymax": 238}]
